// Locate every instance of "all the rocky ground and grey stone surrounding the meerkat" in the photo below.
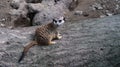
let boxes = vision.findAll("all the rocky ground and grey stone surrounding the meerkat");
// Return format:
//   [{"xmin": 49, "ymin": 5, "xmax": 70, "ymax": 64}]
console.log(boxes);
[{"xmin": 0, "ymin": 0, "xmax": 120, "ymax": 67}]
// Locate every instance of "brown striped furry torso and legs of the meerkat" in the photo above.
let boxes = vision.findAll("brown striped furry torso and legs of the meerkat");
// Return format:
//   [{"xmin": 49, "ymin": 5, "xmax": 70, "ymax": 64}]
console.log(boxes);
[{"xmin": 36, "ymin": 23, "xmax": 60, "ymax": 45}]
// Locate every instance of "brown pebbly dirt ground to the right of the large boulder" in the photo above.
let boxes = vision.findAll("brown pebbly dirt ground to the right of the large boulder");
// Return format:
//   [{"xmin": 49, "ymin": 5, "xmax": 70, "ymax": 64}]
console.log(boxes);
[{"xmin": 69, "ymin": 0, "xmax": 120, "ymax": 21}]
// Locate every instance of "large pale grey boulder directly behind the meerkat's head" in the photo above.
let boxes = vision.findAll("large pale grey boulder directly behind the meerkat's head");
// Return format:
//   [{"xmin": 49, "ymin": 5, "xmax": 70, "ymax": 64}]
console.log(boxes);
[{"xmin": 33, "ymin": 3, "xmax": 67, "ymax": 25}]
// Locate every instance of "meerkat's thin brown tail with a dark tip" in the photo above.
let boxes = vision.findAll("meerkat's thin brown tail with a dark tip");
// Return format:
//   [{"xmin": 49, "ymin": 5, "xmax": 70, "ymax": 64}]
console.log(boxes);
[{"xmin": 18, "ymin": 41, "xmax": 37, "ymax": 63}]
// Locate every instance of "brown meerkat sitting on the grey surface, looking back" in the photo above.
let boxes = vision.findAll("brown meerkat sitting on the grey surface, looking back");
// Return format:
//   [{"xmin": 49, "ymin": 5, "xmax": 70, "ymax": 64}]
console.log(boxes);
[{"xmin": 18, "ymin": 17, "xmax": 65, "ymax": 62}]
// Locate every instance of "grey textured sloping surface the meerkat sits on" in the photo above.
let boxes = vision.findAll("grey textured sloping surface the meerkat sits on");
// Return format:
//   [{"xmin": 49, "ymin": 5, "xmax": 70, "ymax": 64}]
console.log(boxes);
[{"xmin": 0, "ymin": 15, "xmax": 120, "ymax": 67}]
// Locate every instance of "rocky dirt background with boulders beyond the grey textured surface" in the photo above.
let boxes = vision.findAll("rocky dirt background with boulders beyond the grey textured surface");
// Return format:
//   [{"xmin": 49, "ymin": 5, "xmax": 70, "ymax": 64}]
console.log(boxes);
[{"xmin": 0, "ymin": 0, "xmax": 120, "ymax": 28}]
